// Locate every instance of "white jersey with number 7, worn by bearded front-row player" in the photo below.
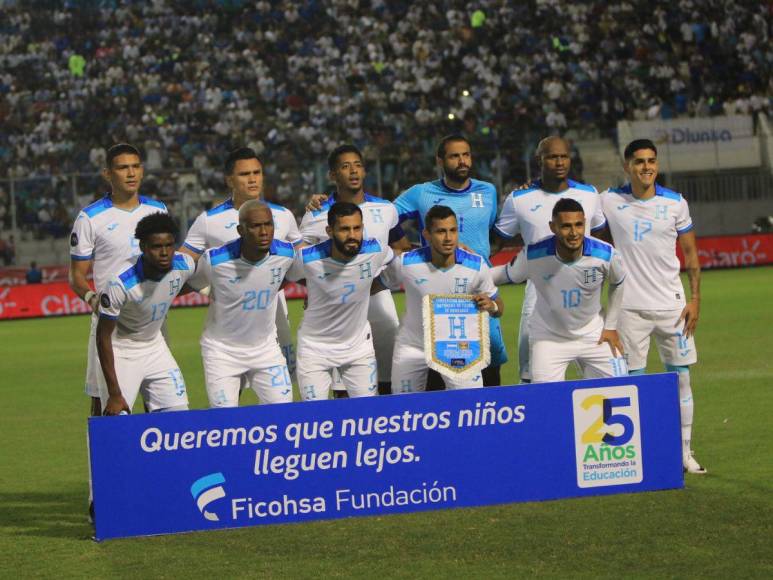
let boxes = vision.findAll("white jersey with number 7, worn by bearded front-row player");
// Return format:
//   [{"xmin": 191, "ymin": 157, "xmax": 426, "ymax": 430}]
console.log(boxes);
[{"xmin": 287, "ymin": 239, "xmax": 394, "ymax": 345}]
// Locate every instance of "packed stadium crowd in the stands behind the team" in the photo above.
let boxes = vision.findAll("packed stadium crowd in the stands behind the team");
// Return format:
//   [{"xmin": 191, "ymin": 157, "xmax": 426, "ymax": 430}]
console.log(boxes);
[{"xmin": 0, "ymin": 0, "xmax": 773, "ymax": 236}]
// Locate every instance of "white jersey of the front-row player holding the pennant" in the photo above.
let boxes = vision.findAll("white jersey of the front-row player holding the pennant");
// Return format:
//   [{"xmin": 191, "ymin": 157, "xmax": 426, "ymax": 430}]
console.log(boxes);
[{"xmin": 380, "ymin": 247, "xmax": 497, "ymax": 348}]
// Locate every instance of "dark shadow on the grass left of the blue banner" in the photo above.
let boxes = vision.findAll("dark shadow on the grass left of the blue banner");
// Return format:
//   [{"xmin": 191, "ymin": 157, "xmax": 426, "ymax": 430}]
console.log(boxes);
[{"xmin": 0, "ymin": 488, "xmax": 94, "ymax": 541}]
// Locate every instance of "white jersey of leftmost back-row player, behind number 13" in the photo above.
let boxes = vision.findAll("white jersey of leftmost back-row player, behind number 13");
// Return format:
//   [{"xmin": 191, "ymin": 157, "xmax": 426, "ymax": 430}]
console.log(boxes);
[{"xmin": 70, "ymin": 194, "xmax": 166, "ymax": 291}]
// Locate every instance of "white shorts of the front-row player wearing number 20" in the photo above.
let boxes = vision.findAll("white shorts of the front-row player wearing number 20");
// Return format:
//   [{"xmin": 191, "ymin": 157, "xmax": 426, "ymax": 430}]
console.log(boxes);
[{"xmin": 201, "ymin": 338, "xmax": 293, "ymax": 407}]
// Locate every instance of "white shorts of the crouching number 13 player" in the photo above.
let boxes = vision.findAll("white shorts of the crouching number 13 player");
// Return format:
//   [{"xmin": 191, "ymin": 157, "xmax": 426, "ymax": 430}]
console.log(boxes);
[{"xmin": 99, "ymin": 332, "xmax": 188, "ymax": 412}]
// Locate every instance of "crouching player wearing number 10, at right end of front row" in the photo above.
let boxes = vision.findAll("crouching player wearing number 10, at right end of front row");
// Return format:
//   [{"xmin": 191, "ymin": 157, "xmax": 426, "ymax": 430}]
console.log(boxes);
[{"xmin": 494, "ymin": 198, "xmax": 627, "ymax": 383}]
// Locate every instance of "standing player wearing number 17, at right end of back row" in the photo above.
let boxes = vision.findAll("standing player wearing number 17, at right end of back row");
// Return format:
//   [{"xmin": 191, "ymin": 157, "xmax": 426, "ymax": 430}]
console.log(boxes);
[{"xmin": 601, "ymin": 139, "xmax": 706, "ymax": 474}]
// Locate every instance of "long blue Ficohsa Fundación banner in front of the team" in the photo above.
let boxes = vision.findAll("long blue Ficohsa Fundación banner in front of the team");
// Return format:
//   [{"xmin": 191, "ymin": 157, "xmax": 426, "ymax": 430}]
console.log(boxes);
[{"xmin": 89, "ymin": 373, "xmax": 684, "ymax": 540}]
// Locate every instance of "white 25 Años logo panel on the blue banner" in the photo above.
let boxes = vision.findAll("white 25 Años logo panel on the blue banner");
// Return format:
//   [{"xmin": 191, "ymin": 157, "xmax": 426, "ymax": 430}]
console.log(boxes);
[{"xmin": 572, "ymin": 385, "xmax": 644, "ymax": 487}]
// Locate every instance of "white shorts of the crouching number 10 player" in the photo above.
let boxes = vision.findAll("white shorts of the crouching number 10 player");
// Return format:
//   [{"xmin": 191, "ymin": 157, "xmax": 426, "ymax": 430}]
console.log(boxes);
[{"xmin": 529, "ymin": 336, "xmax": 628, "ymax": 383}]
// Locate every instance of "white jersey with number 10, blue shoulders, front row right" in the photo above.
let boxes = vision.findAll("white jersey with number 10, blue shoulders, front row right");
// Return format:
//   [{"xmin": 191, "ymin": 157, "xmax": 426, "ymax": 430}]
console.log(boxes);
[{"xmin": 505, "ymin": 236, "xmax": 625, "ymax": 340}]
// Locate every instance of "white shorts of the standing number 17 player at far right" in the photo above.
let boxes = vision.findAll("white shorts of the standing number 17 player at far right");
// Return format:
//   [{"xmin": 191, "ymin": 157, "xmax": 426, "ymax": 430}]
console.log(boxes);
[{"xmin": 617, "ymin": 309, "xmax": 698, "ymax": 370}]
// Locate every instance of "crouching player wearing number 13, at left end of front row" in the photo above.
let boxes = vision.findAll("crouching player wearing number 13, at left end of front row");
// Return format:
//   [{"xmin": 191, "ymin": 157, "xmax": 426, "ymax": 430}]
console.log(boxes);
[{"xmin": 97, "ymin": 212, "xmax": 195, "ymax": 415}]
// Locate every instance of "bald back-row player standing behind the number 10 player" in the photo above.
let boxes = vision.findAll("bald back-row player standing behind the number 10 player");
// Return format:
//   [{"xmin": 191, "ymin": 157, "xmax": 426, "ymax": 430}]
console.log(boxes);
[{"xmin": 494, "ymin": 137, "xmax": 606, "ymax": 383}]
